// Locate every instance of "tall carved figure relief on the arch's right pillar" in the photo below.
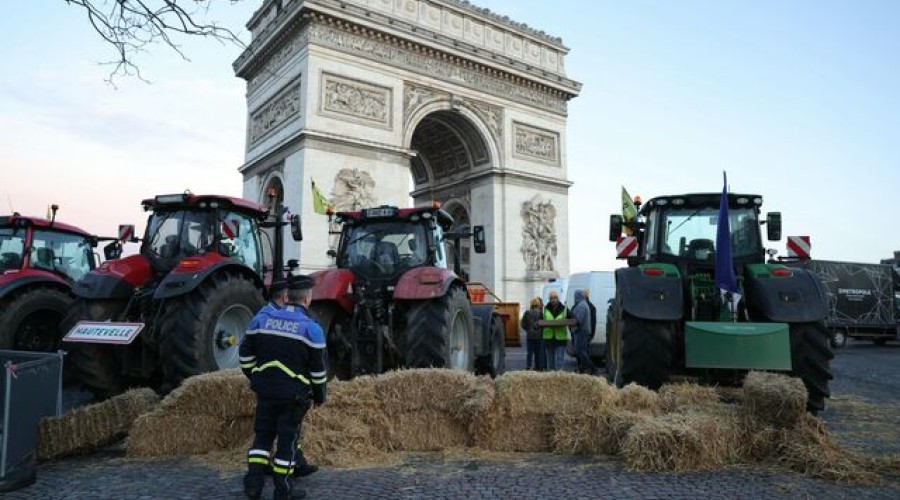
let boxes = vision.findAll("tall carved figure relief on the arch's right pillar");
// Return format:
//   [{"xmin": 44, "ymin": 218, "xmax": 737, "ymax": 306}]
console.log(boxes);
[{"xmin": 521, "ymin": 195, "xmax": 557, "ymax": 273}]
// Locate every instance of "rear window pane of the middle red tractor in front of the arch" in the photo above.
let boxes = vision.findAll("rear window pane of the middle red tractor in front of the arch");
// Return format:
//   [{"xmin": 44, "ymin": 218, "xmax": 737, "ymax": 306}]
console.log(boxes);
[{"xmin": 338, "ymin": 221, "xmax": 428, "ymax": 277}]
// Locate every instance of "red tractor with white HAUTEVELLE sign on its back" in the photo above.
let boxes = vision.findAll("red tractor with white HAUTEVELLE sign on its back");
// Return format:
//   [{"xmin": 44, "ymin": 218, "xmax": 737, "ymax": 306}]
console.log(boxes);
[{"xmin": 62, "ymin": 192, "xmax": 301, "ymax": 398}]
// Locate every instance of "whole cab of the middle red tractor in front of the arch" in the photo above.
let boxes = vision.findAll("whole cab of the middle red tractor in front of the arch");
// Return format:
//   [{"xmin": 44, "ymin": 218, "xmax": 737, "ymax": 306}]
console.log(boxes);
[{"xmin": 334, "ymin": 206, "xmax": 453, "ymax": 282}]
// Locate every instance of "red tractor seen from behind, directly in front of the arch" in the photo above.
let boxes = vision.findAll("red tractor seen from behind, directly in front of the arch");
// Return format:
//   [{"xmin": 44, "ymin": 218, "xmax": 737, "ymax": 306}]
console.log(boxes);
[{"xmin": 312, "ymin": 205, "xmax": 505, "ymax": 379}]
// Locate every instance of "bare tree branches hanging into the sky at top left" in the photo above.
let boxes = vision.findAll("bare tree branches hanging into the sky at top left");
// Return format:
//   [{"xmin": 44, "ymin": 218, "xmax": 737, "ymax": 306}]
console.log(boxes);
[{"xmin": 64, "ymin": 0, "xmax": 245, "ymax": 83}]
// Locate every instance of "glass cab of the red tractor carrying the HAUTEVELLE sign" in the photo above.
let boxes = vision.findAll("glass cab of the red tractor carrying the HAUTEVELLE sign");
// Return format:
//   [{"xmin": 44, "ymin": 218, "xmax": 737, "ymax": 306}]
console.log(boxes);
[{"xmin": 140, "ymin": 193, "xmax": 268, "ymax": 276}]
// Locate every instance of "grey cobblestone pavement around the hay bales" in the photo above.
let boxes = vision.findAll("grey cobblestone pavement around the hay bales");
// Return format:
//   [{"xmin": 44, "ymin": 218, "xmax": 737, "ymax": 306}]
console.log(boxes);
[{"xmin": 8, "ymin": 343, "xmax": 900, "ymax": 500}]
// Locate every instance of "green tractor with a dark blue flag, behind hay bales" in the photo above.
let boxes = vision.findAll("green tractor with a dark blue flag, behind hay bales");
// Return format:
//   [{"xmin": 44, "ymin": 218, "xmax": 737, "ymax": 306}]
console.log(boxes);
[{"xmin": 606, "ymin": 192, "xmax": 834, "ymax": 413}]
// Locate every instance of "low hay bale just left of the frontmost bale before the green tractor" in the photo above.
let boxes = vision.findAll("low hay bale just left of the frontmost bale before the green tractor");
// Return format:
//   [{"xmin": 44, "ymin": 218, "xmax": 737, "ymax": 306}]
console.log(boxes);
[{"xmin": 551, "ymin": 408, "xmax": 652, "ymax": 455}]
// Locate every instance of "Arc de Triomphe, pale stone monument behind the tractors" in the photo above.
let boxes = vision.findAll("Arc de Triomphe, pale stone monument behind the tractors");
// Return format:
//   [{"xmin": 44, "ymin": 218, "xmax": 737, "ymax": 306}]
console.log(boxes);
[{"xmin": 234, "ymin": 0, "xmax": 581, "ymax": 303}]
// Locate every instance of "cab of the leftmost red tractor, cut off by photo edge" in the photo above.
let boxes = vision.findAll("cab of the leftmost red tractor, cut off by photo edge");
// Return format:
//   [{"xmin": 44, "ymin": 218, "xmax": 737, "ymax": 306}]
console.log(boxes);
[{"xmin": 0, "ymin": 214, "xmax": 96, "ymax": 281}]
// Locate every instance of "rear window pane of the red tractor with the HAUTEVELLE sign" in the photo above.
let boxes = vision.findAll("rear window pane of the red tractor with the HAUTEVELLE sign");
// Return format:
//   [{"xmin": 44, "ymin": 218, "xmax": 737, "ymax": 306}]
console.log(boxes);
[{"xmin": 144, "ymin": 210, "xmax": 215, "ymax": 260}]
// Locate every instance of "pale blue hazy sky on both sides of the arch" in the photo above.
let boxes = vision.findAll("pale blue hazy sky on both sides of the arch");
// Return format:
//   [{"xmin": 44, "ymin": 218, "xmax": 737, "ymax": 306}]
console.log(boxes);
[{"xmin": 0, "ymin": 0, "xmax": 900, "ymax": 271}]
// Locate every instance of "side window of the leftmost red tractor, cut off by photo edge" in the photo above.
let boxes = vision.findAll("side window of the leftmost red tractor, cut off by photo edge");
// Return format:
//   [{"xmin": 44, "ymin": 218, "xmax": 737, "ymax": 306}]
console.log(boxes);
[{"xmin": 29, "ymin": 229, "xmax": 94, "ymax": 281}]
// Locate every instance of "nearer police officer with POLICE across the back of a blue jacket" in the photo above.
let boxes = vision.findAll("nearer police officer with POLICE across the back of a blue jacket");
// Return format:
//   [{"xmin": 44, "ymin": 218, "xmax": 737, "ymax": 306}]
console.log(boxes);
[{"xmin": 240, "ymin": 276, "xmax": 326, "ymax": 500}]
